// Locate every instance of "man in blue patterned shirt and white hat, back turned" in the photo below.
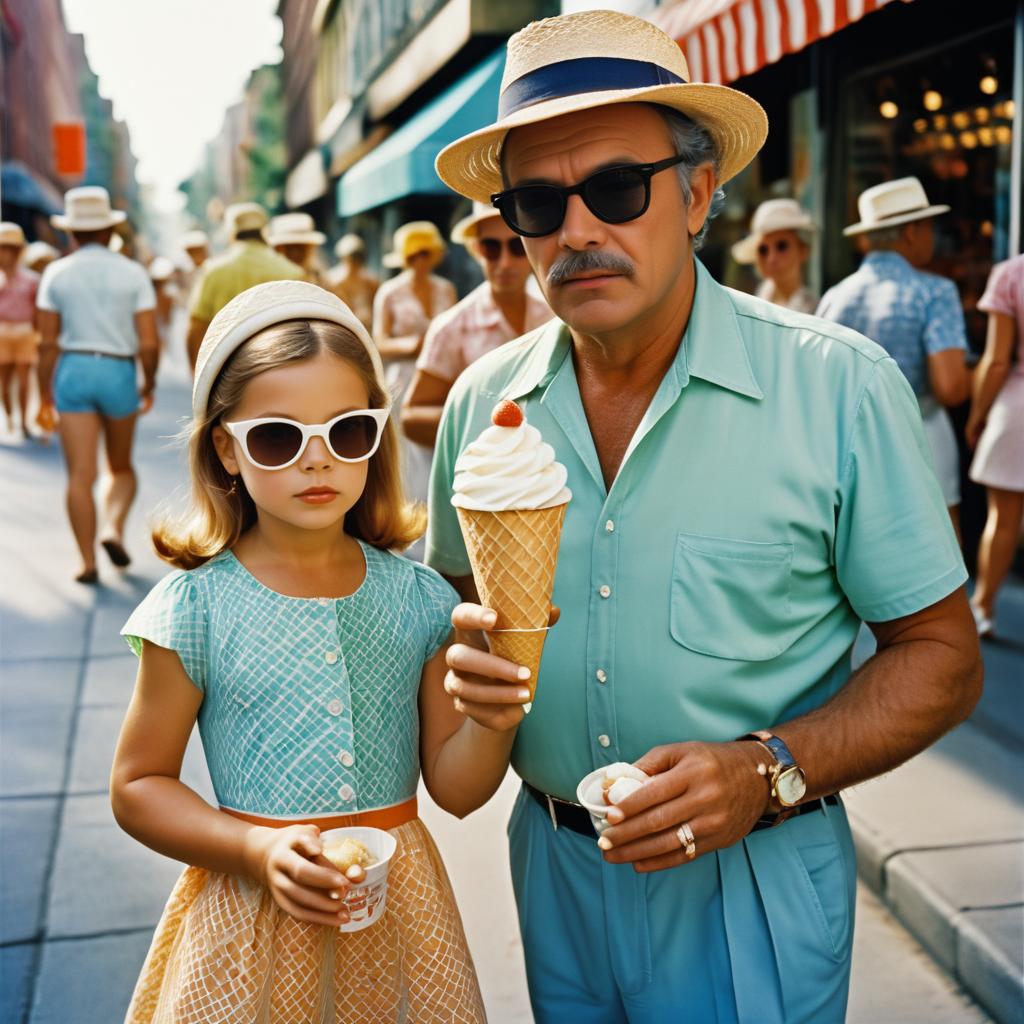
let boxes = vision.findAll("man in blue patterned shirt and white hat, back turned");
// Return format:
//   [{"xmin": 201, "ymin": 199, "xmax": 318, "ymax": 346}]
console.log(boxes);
[{"xmin": 818, "ymin": 177, "xmax": 971, "ymax": 534}]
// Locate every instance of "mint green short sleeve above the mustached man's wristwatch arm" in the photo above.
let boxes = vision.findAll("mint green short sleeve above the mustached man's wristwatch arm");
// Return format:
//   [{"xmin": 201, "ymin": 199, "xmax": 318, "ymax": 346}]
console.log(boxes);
[{"xmin": 836, "ymin": 358, "xmax": 967, "ymax": 623}]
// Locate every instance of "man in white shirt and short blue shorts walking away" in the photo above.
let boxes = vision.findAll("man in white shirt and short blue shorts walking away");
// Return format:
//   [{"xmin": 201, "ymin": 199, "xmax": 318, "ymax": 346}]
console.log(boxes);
[{"xmin": 36, "ymin": 186, "xmax": 160, "ymax": 584}]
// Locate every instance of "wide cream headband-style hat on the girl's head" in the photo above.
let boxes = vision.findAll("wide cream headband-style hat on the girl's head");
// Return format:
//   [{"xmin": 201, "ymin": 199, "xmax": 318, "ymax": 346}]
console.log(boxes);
[{"xmin": 193, "ymin": 281, "xmax": 388, "ymax": 420}]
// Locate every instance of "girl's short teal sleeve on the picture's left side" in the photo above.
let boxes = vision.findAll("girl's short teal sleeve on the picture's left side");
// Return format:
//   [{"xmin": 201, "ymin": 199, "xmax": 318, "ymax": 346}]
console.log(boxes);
[{"xmin": 121, "ymin": 570, "xmax": 207, "ymax": 692}]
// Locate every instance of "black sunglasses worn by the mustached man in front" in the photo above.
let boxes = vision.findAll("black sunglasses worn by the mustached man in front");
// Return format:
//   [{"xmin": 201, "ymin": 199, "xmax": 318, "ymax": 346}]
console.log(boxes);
[{"xmin": 490, "ymin": 155, "xmax": 686, "ymax": 239}]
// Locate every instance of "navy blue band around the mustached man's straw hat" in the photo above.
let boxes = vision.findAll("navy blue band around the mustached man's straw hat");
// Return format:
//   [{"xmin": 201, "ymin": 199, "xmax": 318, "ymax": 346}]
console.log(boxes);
[{"xmin": 498, "ymin": 57, "xmax": 687, "ymax": 120}]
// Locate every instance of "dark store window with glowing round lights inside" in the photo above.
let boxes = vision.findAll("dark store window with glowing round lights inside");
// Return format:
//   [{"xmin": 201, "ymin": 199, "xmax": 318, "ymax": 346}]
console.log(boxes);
[{"xmin": 844, "ymin": 23, "xmax": 1017, "ymax": 351}]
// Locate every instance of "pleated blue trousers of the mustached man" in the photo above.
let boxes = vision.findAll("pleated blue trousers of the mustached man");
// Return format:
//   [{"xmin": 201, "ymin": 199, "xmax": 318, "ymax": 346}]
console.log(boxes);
[{"xmin": 509, "ymin": 791, "xmax": 856, "ymax": 1024}]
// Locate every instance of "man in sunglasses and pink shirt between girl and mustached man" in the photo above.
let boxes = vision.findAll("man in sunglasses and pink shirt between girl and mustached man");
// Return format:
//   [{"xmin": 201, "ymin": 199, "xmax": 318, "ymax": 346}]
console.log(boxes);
[{"xmin": 401, "ymin": 203, "xmax": 551, "ymax": 446}]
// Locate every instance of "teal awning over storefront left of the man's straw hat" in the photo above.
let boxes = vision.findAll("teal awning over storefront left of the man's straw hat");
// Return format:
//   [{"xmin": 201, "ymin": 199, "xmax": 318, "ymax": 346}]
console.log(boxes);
[{"xmin": 338, "ymin": 46, "xmax": 505, "ymax": 217}]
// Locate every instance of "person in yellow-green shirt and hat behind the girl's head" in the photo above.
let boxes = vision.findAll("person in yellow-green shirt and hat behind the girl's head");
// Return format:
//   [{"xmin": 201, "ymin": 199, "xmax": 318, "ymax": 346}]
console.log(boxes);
[{"xmin": 185, "ymin": 203, "xmax": 304, "ymax": 367}]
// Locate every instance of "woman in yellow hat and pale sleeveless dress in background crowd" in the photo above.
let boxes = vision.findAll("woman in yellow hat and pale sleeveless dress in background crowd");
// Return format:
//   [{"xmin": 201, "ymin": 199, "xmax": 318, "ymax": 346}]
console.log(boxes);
[{"xmin": 373, "ymin": 220, "xmax": 458, "ymax": 499}]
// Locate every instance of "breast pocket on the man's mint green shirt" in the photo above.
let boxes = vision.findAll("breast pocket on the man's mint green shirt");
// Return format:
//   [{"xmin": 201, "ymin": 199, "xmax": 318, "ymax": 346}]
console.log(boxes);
[{"xmin": 669, "ymin": 532, "xmax": 797, "ymax": 662}]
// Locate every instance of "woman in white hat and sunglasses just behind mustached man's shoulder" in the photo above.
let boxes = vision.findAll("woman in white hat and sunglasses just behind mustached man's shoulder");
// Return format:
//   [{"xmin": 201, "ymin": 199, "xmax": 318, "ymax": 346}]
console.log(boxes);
[{"xmin": 732, "ymin": 199, "xmax": 818, "ymax": 313}]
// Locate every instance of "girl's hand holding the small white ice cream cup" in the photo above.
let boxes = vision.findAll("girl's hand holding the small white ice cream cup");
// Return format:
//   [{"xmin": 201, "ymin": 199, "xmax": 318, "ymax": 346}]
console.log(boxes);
[{"xmin": 251, "ymin": 825, "xmax": 365, "ymax": 928}]
